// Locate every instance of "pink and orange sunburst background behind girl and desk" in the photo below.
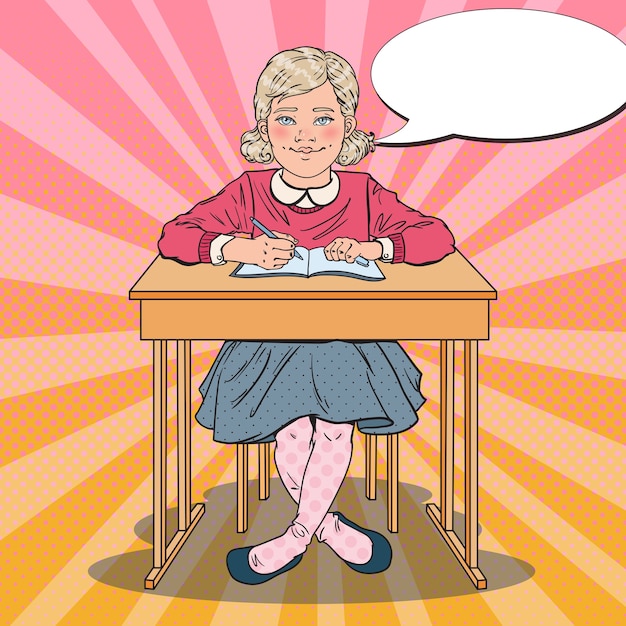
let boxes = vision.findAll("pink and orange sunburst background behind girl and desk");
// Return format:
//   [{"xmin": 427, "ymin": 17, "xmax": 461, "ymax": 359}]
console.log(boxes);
[{"xmin": 0, "ymin": 0, "xmax": 626, "ymax": 625}]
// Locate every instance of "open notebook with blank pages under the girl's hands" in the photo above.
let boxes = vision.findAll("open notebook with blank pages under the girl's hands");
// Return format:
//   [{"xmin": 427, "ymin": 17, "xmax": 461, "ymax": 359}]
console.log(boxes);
[{"xmin": 231, "ymin": 246, "xmax": 385, "ymax": 280}]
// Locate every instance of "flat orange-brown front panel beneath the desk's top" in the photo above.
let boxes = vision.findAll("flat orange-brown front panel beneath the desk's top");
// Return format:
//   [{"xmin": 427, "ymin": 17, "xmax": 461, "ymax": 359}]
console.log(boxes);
[{"xmin": 141, "ymin": 300, "xmax": 489, "ymax": 340}]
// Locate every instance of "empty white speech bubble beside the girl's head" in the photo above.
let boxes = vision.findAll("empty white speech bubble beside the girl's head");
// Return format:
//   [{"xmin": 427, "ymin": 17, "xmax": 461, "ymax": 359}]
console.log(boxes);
[{"xmin": 372, "ymin": 9, "xmax": 626, "ymax": 146}]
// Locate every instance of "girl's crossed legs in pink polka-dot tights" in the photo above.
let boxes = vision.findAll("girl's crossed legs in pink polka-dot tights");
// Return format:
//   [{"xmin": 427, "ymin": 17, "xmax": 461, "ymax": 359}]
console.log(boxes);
[{"xmin": 248, "ymin": 417, "xmax": 372, "ymax": 574}]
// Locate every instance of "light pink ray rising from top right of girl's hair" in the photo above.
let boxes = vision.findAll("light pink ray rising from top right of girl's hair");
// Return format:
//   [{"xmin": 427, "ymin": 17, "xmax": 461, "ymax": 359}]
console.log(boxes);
[{"xmin": 324, "ymin": 0, "xmax": 369, "ymax": 76}]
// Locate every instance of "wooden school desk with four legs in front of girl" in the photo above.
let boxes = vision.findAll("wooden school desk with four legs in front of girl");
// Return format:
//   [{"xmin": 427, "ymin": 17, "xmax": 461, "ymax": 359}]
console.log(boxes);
[{"xmin": 130, "ymin": 252, "xmax": 496, "ymax": 589}]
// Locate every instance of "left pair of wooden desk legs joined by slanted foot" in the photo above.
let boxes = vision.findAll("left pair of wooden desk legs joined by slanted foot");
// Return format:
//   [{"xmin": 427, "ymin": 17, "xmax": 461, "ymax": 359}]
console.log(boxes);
[{"xmin": 144, "ymin": 340, "xmax": 204, "ymax": 589}]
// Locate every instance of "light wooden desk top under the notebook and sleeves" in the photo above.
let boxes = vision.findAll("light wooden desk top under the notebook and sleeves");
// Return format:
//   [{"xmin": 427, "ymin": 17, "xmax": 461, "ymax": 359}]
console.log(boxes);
[{"xmin": 129, "ymin": 251, "xmax": 497, "ymax": 300}]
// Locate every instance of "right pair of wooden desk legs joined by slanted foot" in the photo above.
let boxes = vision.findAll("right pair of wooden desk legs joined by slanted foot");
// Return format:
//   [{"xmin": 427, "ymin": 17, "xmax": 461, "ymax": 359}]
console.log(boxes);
[{"xmin": 426, "ymin": 340, "xmax": 487, "ymax": 589}]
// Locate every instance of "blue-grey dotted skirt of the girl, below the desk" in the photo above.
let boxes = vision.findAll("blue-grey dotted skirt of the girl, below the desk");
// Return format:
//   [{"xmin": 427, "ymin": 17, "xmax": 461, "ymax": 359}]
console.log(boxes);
[{"xmin": 196, "ymin": 341, "xmax": 425, "ymax": 443}]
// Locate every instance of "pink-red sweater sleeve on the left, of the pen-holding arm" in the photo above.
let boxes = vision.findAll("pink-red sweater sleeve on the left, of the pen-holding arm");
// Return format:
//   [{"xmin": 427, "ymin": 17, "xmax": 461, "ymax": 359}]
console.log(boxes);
[{"xmin": 158, "ymin": 173, "xmax": 252, "ymax": 264}]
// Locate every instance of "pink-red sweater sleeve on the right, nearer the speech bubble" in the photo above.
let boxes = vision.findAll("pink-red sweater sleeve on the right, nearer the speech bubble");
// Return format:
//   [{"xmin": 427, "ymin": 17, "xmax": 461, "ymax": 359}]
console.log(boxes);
[{"xmin": 368, "ymin": 178, "xmax": 454, "ymax": 265}]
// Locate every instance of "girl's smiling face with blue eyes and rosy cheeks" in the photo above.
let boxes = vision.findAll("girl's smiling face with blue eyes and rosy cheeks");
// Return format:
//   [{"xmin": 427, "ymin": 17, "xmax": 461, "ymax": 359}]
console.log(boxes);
[{"xmin": 258, "ymin": 81, "xmax": 356, "ymax": 186}]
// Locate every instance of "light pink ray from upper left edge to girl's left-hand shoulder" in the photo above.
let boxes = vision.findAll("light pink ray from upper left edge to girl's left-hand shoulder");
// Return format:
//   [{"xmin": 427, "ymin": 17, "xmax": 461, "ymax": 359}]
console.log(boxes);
[{"xmin": 0, "ymin": 50, "xmax": 189, "ymax": 221}]
